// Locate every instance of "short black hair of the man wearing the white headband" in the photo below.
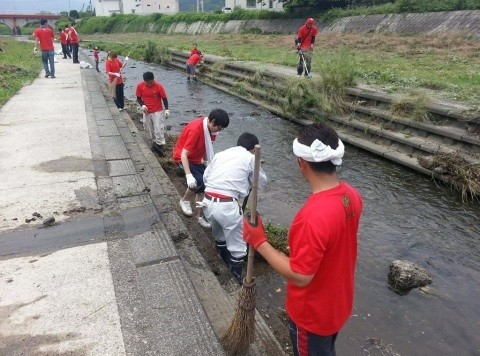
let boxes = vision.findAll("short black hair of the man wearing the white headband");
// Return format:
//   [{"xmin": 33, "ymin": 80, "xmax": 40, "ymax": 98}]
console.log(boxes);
[{"xmin": 298, "ymin": 123, "xmax": 338, "ymax": 174}]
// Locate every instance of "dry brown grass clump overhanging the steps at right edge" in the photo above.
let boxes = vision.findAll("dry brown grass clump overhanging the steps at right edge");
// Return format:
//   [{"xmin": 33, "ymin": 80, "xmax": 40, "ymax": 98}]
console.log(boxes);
[{"xmin": 432, "ymin": 154, "xmax": 480, "ymax": 201}]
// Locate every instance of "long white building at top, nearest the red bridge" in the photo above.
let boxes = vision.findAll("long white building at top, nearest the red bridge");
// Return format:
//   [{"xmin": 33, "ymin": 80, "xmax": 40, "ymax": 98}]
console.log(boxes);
[{"xmin": 95, "ymin": 0, "xmax": 179, "ymax": 16}]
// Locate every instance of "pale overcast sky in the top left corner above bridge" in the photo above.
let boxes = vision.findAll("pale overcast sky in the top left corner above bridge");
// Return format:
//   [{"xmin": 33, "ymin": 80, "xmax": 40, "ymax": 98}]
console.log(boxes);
[{"xmin": 0, "ymin": 0, "xmax": 87, "ymax": 14}]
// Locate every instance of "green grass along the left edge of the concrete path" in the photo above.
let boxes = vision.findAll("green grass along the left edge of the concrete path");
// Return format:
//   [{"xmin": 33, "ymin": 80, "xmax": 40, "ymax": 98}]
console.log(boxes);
[{"xmin": 0, "ymin": 38, "xmax": 42, "ymax": 106}]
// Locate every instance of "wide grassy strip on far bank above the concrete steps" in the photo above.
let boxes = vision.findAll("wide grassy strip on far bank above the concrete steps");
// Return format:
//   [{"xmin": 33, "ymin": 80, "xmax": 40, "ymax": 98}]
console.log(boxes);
[{"xmin": 83, "ymin": 33, "xmax": 480, "ymax": 107}]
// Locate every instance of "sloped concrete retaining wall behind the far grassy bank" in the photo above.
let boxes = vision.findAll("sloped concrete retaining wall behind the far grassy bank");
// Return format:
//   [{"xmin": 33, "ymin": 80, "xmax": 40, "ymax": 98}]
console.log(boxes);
[{"xmin": 161, "ymin": 11, "xmax": 480, "ymax": 37}]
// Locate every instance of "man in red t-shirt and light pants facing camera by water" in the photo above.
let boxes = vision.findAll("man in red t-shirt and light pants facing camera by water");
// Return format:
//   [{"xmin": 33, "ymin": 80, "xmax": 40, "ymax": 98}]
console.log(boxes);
[{"xmin": 135, "ymin": 72, "xmax": 170, "ymax": 156}]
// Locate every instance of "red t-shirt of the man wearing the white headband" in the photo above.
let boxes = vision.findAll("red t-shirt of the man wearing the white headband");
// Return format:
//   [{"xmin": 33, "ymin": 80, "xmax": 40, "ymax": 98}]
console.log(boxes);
[{"xmin": 286, "ymin": 182, "xmax": 363, "ymax": 336}]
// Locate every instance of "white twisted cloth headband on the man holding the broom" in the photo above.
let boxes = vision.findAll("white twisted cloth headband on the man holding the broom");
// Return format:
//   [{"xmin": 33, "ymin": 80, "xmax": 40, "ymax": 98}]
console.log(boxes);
[{"xmin": 293, "ymin": 139, "xmax": 345, "ymax": 166}]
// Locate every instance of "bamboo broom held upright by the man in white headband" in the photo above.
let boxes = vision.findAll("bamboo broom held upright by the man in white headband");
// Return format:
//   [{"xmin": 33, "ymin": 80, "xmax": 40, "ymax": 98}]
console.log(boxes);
[{"xmin": 221, "ymin": 145, "xmax": 261, "ymax": 356}]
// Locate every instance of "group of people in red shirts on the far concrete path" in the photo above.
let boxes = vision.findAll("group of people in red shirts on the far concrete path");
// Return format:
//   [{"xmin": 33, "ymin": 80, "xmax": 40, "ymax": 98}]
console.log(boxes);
[{"xmin": 33, "ymin": 19, "xmax": 80, "ymax": 78}]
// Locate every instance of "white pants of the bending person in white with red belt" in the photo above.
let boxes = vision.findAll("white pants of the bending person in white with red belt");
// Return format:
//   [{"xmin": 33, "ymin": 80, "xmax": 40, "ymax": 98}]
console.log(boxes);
[{"xmin": 203, "ymin": 199, "xmax": 247, "ymax": 258}]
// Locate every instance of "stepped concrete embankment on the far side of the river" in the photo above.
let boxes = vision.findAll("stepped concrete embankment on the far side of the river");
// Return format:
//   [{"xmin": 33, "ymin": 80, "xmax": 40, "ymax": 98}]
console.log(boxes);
[{"xmin": 169, "ymin": 52, "xmax": 480, "ymax": 193}]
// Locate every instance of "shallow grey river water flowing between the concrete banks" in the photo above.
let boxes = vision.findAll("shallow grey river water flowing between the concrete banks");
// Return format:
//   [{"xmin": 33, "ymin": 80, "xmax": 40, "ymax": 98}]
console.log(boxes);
[{"xmin": 97, "ymin": 53, "xmax": 480, "ymax": 356}]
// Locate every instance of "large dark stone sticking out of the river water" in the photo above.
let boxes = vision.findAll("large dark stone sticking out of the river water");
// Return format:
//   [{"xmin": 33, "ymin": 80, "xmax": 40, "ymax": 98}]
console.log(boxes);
[{"xmin": 388, "ymin": 260, "xmax": 432, "ymax": 295}]
